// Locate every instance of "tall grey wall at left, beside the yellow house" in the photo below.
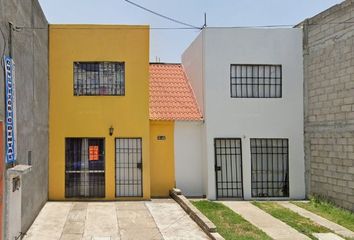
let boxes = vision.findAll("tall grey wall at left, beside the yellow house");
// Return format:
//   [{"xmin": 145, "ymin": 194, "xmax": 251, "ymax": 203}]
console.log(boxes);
[{"xmin": 0, "ymin": 0, "xmax": 48, "ymax": 232}]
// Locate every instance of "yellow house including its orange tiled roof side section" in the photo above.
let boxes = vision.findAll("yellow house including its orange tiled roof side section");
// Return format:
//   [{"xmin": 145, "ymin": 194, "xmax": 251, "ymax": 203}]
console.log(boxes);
[{"xmin": 49, "ymin": 25, "xmax": 201, "ymax": 200}]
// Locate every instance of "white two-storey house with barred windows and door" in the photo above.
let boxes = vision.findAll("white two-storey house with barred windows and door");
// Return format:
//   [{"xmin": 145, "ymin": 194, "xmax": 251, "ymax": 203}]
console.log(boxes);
[{"xmin": 181, "ymin": 28, "xmax": 305, "ymax": 199}]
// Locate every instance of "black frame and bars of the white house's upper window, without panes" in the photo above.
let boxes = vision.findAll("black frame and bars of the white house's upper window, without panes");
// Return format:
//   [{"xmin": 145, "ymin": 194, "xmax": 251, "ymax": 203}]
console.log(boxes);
[{"xmin": 230, "ymin": 63, "xmax": 283, "ymax": 99}]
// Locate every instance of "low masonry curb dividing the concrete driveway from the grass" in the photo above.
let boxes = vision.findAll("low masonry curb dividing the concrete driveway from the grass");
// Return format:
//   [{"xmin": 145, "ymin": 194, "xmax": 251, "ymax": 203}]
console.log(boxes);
[{"xmin": 170, "ymin": 188, "xmax": 224, "ymax": 240}]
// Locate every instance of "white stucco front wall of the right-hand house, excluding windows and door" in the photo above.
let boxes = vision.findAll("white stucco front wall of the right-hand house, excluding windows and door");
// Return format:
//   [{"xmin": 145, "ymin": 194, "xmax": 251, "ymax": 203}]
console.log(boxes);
[{"xmin": 182, "ymin": 28, "xmax": 305, "ymax": 199}]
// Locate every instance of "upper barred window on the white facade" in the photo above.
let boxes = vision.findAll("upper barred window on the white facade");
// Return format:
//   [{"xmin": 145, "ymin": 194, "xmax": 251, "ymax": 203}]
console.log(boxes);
[{"xmin": 230, "ymin": 64, "xmax": 282, "ymax": 98}]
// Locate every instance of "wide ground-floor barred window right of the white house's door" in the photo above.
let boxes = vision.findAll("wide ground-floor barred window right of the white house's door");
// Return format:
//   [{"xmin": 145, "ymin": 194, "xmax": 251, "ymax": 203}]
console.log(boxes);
[{"xmin": 251, "ymin": 138, "xmax": 289, "ymax": 197}]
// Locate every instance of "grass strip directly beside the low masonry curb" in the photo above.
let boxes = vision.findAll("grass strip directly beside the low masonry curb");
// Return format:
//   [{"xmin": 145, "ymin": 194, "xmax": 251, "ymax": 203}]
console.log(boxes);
[{"xmin": 192, "ymin": 201, "xmax": 271, "ymax": 240}]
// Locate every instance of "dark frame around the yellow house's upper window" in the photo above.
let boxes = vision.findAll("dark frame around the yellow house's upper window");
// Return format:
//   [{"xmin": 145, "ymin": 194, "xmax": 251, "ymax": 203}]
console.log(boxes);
[{"xmin": 72, "ymin": 61, "xmax": 126, "ymax": 97}]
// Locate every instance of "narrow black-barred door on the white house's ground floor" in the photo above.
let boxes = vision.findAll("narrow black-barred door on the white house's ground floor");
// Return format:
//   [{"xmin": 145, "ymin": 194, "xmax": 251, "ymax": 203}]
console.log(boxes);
[{"xmin": 214, "ymin": 138, "xmax": 243, "ymax": 198}]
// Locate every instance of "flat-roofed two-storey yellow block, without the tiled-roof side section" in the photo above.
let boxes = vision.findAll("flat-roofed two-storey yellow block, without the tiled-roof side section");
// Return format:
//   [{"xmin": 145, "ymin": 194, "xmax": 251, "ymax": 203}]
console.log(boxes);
[{"xmin": 49, "ymin": 25, "xmax": 150, "ymax": 200}]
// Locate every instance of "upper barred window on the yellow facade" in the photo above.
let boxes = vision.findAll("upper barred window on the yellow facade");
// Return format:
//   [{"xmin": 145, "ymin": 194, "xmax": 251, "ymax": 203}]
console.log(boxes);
[{"xmin": 74, "ymin": 62, "xmax": 125, "ymax": 96}]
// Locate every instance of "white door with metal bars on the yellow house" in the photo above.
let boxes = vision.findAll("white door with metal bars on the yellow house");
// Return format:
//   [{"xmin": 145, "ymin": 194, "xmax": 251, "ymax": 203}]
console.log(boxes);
[{"xmin": 116, "ymin": 138, "xmax": 143, "ymax": 197}]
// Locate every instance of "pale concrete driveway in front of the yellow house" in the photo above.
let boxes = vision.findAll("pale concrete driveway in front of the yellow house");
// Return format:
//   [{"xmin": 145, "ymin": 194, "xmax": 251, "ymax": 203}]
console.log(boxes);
[{"xmin": 24, "ymin": 199, "xmax": 209, "ymax": 240}]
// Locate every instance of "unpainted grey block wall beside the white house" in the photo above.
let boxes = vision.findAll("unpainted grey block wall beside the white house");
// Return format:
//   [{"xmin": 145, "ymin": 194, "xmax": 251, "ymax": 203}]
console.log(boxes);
[{"xmin": 303, "ymin": 1, "xmax": 354, "ymax": 210}]
